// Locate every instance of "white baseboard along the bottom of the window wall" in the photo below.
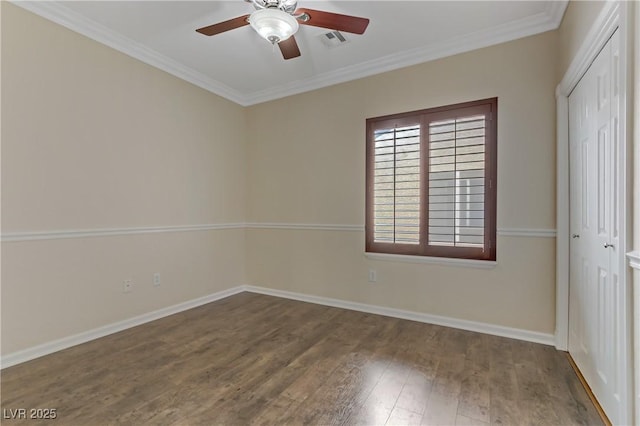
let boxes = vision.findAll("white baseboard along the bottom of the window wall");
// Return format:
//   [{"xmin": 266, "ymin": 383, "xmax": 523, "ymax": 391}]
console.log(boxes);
[{"xmin": 244, "ymin": 286, "xmax": 554, "ymax": 346}]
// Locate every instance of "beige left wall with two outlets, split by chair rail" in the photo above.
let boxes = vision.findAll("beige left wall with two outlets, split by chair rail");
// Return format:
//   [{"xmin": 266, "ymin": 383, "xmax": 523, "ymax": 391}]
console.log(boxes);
[{"xmin": 1, "ymin": 2, "xmax": 246, "ymax": 354}]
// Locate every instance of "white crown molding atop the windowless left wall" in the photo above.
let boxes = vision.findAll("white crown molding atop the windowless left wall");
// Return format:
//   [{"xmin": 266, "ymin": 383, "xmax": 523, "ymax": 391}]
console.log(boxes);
[{"xmin": 10, "ymin": 0, "xmax": 243, "ymax": 105}]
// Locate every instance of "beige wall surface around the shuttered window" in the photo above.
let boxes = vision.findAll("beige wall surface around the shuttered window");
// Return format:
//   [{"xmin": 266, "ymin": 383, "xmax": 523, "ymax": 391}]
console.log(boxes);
[{"xmin": 247, "ymin": 32, "xmax": 557, "ymax": 333}]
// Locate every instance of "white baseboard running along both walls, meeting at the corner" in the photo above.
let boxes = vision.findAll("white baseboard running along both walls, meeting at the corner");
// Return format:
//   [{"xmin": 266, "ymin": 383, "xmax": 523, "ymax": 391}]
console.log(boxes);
[{"xmin": 0, "ymin": 285, "xmax": 555, "ymax": 368}]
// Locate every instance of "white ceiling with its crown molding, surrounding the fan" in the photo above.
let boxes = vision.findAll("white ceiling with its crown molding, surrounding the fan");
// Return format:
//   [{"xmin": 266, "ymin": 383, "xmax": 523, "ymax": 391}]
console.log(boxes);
[{"xmin": 16, "ymin": 0, "xmax": 567, "ymax": 105}]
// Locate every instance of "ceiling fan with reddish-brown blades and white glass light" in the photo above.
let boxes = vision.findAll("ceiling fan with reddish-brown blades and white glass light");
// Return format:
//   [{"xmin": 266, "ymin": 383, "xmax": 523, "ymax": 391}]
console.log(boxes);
[{"xmin": 196, "ymin": 0, "xmax": 369, "ymax": 59}]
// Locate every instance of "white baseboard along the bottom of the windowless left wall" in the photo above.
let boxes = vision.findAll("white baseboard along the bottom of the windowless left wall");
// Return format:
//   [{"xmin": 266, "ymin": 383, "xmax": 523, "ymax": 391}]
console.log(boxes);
[{"xmin": 0, "ymin": 286, "xmax": 244, "ymax": 368}]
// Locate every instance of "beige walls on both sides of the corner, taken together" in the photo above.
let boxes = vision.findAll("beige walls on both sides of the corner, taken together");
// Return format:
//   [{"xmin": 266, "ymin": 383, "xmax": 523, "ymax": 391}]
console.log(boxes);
[{"xmin": 1, "ymin": 2, "xmax": 558, "ymax": 355}]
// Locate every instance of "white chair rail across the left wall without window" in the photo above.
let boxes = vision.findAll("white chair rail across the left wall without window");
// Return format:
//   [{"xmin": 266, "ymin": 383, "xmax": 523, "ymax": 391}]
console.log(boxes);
[{"xmin": 0, "ymin": 223, "xmax": 244, "ymax": 243}]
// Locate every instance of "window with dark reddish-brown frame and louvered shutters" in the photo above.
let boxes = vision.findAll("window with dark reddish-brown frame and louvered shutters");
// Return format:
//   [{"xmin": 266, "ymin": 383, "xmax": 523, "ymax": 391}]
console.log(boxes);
[{"xmin": 366, "ymin": 98, "xmax": 498, "ymax": 260}]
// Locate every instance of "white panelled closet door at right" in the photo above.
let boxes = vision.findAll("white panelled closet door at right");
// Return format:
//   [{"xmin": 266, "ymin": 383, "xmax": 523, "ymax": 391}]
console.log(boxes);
[{"xmin": 569, "ymin": 32, "xmax": 625, "ymax": 424}]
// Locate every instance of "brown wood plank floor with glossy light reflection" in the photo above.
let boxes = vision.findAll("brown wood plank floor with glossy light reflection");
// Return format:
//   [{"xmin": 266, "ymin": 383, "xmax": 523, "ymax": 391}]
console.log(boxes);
[{"xmin": 0, "ymin": 293, "xmax": 602, "ymax": 426}]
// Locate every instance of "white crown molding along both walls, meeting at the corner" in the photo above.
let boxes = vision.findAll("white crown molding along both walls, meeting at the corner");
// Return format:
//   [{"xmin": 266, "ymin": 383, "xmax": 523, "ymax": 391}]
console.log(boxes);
[{"xmin": 12, "ymin": 0, "xmax": 568, "ymax": 106}]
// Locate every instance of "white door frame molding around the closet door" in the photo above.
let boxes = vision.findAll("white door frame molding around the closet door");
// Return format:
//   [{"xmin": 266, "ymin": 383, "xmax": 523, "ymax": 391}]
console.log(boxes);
[{"xmin": 555, "ymin": 1, "xmax": 634, "ymax": 424}]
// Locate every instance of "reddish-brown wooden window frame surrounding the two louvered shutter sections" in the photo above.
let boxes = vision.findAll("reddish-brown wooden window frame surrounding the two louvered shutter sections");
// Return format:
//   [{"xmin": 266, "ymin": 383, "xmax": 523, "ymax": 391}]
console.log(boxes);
[{"xmin": 365, "ymin": 98, "xmax": 498, "ymax": 261}]
